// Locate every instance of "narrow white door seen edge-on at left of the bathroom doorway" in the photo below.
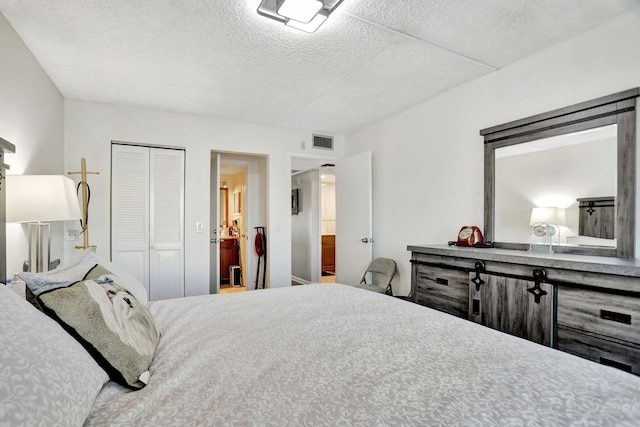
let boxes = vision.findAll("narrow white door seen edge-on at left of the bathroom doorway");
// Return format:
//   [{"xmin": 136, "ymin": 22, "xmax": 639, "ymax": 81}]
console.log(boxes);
[{"xmin": 209, "ymin": 154, "xmax": 221, "ymax": 294}]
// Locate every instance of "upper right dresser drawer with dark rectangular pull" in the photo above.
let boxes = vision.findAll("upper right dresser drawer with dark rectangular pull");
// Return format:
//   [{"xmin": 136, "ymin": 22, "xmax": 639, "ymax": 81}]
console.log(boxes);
[{"xmin": 558, "ymin": 286, "xmax": 640, "ymax": 344}]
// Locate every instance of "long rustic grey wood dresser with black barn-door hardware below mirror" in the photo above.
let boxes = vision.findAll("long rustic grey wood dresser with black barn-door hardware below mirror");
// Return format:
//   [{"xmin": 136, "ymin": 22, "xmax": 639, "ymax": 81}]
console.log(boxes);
[{"xmin": 407, "ymin": 245, "xmax": 640, "ymax": 375}]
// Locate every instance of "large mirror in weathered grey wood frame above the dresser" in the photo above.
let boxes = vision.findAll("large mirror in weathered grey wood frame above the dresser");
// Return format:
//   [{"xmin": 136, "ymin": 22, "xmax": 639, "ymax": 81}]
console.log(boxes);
[{"xmin": 480, "ymin": 88, "xmax": 640, "ymax": 258}]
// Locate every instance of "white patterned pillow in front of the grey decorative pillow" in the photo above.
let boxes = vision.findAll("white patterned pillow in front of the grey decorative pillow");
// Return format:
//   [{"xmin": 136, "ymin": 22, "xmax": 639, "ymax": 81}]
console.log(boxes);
[{"xmin": 0, "ymin": 285, "xmax": 109, "ymax": 426}]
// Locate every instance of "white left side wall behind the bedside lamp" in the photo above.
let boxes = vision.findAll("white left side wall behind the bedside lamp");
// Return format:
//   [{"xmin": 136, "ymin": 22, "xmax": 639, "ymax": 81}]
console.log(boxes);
[{"xmin": 0, "ymin": 14, "xmax": 64, "ymax": 274}]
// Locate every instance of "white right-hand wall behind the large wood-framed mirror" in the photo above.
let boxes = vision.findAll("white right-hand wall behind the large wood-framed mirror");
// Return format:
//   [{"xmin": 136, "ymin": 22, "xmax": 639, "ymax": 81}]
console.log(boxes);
[{"xmin": 345, "ymin": 12, "xmax": 640, "ymax": 294}]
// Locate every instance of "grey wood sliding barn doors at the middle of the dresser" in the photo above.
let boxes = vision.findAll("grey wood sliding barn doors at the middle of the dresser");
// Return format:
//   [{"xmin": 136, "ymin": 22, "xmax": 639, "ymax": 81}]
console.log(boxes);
[{"xmin": 469, "ymin": 273, "xmax": 554, "ymax": 346}]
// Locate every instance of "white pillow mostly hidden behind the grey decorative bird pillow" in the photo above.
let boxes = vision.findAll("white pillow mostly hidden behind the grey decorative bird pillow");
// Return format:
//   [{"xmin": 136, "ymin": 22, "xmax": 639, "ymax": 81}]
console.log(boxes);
[{"xmin": 18, "ymin": 248, "xmax": 149, "ymax": 308}]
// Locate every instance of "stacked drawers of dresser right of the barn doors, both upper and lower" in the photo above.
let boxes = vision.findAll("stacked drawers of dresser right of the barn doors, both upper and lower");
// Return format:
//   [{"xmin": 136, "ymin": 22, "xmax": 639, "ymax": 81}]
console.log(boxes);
[{"xmin": 557, "ymin": 286, "xmax": 640, "ymax": 375}]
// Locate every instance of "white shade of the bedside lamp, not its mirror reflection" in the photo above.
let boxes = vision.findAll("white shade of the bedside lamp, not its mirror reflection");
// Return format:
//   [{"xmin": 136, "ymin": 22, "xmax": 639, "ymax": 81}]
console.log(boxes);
[{"xmin": 6, "ymin": 175, "xmax": 82, "ymax": 222}]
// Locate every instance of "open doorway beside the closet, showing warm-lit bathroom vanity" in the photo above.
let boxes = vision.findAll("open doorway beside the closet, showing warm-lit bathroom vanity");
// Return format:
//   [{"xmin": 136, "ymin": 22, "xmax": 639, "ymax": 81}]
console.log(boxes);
[{"xmin": 209, "ymin": 151, "xmax": 269, "ymax": 294}]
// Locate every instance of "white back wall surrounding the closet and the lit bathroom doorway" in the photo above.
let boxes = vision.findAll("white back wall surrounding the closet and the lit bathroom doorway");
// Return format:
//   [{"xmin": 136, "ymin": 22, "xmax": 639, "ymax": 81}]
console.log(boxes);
[{"xmin": 64, "ymin": 100, "xmax": 343, "ymax": 295}]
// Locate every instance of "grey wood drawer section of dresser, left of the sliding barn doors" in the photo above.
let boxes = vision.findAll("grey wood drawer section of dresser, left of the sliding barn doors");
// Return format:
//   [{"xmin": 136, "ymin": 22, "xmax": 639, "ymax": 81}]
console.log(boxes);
[{"xmin": 414, "ymin": 265, "xmax": 469, "ymax": 318}]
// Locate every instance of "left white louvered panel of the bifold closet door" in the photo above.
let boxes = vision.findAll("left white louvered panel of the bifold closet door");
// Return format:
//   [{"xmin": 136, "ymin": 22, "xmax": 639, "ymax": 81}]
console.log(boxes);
[{"xmin": 111, "ymin": 144, "xmax": 149, "ymax": 293}]
